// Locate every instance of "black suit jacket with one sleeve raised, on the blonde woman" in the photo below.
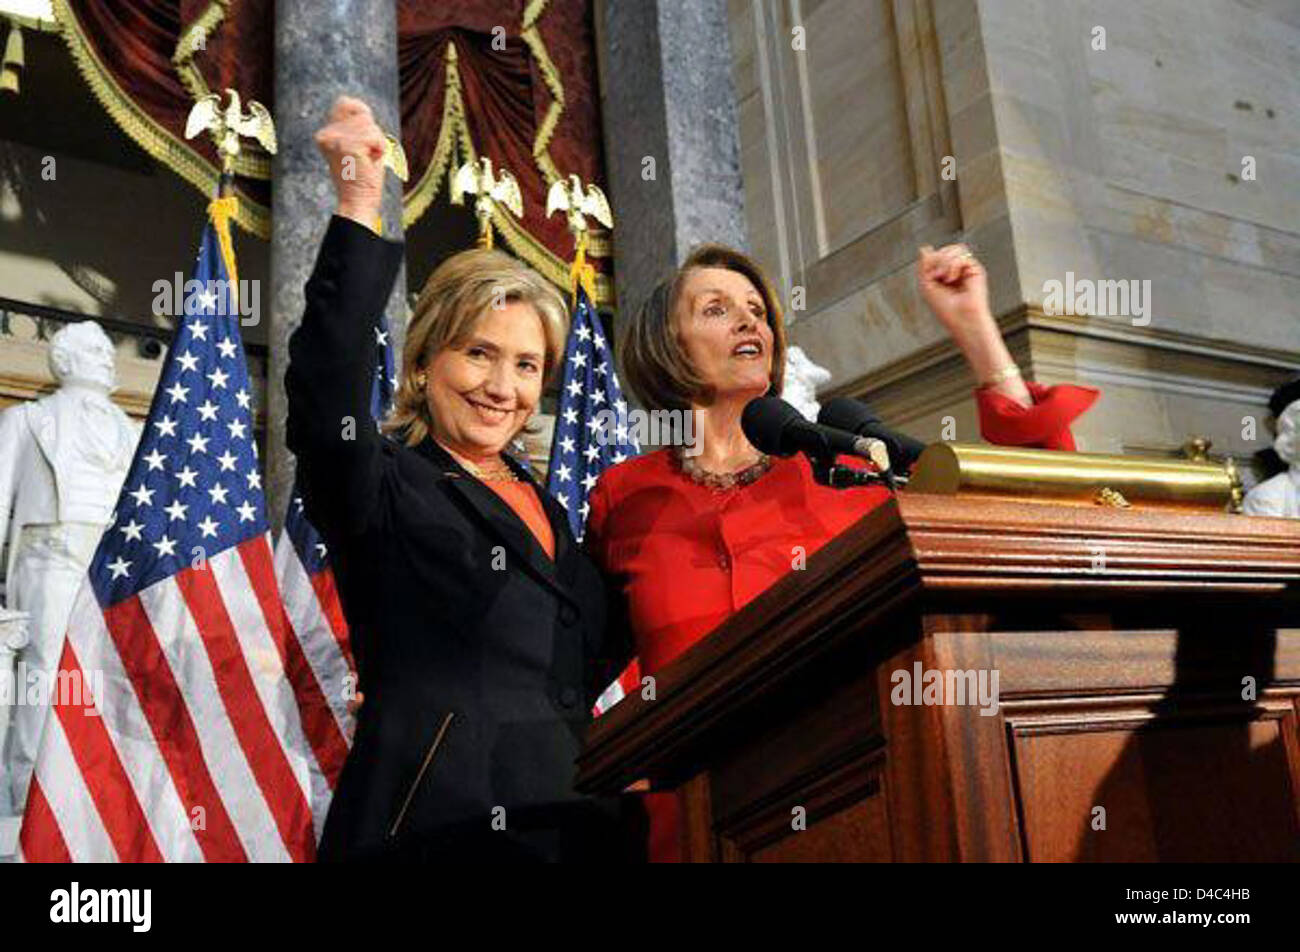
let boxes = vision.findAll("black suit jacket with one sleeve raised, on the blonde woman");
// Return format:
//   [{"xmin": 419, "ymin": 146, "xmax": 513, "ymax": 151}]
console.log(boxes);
[{"xmin": 285, "ymin": 217, "xmax": 631, "ymax": 861}]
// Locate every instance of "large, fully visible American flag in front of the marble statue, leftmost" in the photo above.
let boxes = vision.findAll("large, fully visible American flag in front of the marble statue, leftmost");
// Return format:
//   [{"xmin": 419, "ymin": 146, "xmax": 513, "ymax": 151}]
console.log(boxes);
[{"xmin": 20, "ymin": 199, "xmax": 321, "ymax": 861}]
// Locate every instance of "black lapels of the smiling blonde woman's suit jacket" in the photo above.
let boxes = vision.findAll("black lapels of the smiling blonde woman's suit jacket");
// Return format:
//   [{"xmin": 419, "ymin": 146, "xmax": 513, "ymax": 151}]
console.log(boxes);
[{"xmin": 415, "ymin": 437, "xmax": 577, "ymax": 601}]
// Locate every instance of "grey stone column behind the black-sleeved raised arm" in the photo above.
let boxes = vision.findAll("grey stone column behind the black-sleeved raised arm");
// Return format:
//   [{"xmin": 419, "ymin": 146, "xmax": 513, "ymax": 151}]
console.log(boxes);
[{"xmin": 267, "ymin": 0, "xmax": 406, "ymax": 531}]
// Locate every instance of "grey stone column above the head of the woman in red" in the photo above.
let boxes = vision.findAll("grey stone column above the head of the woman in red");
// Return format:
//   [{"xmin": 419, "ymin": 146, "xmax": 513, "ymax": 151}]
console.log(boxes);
[{"xmin": 597, "ymin": 0, "xmax": 748, "ymax": 319}]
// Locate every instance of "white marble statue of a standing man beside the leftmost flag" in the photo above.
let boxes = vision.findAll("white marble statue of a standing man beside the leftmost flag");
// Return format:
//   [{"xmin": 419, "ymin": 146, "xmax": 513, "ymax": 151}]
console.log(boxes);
[{"xmin": 0, "ymin": 321, "xmax": 139, "ymax": 812}]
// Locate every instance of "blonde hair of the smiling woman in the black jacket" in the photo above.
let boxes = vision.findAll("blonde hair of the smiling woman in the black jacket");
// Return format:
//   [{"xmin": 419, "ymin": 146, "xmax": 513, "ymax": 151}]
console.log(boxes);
[{"xmin": 382, "ymin": 248, "xmax": 568, "ymax": 446}]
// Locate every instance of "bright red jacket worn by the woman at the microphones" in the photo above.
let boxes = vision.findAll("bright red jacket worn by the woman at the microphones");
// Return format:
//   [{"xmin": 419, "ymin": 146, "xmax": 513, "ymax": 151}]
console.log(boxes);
[{"xmin": 586, "ymin": 384, "xmax": 1097, "ymax": 860}]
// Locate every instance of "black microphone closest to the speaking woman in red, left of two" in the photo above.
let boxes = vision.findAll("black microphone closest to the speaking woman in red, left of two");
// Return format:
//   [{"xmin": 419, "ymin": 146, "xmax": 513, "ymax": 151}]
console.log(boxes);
[{"xmin": 740, "ymin": 397, "xmax": 893, "ymax": 488}]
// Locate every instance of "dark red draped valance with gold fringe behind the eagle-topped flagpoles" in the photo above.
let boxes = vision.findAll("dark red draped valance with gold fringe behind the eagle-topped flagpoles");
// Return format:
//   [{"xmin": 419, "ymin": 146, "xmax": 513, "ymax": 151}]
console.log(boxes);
[{"xmin": 55, "ymin": 0, "xmax": 611, "ymax": 302}]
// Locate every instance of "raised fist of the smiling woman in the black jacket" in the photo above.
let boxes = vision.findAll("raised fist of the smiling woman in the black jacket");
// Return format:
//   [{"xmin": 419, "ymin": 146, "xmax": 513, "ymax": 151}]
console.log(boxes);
[{"xmin": 316, "ymin": 96, "xmax": 385, "ymax": 228}]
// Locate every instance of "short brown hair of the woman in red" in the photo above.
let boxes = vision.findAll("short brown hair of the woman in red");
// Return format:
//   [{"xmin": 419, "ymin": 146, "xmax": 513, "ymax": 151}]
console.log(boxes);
[{"xmin": 623, "ymin": 245, "xmax": 785, "ymax": 410}]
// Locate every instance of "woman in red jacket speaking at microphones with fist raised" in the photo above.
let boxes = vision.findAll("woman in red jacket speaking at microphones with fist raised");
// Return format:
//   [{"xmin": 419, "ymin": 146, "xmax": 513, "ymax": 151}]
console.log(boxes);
[{"xmin": 586, "ymin": 245, "xmax": 1097, "ymax": 861}]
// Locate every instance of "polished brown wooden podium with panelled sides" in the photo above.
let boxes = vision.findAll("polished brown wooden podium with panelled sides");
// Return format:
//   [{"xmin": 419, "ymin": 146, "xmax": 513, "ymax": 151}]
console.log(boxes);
[{"xmin": 579, "ymin": 493, "xmax": 1300, "ymax": 862}]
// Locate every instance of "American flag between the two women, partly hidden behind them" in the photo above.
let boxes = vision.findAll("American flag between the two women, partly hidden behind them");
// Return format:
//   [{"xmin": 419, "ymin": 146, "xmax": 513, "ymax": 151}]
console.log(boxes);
[{"xmin": 546, "ymin": 284, "xmax": 641, "ymax": 715}]
